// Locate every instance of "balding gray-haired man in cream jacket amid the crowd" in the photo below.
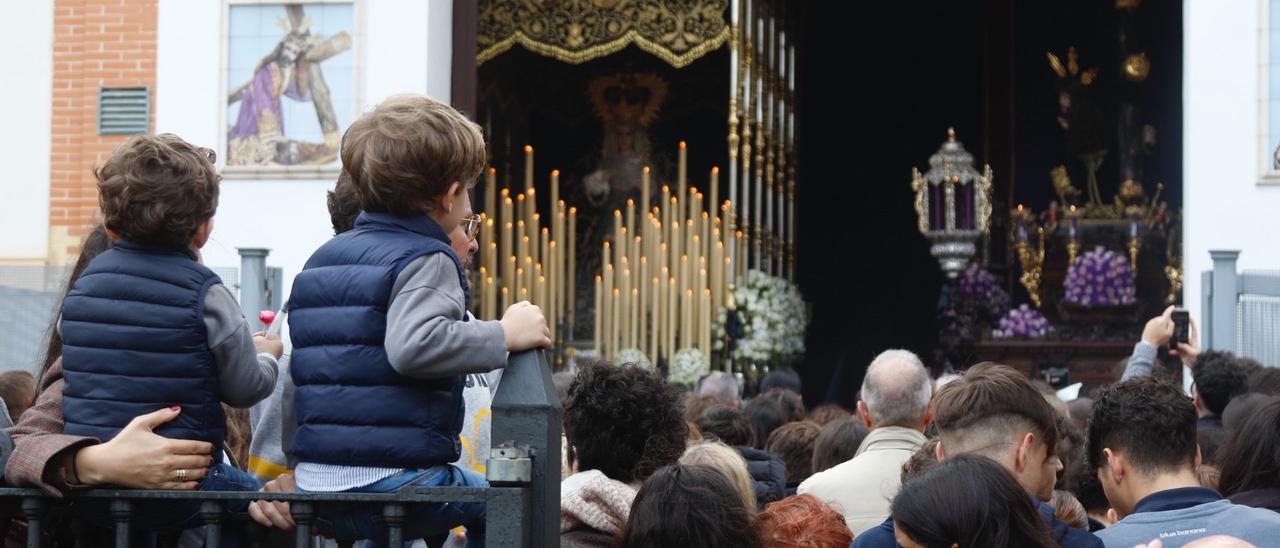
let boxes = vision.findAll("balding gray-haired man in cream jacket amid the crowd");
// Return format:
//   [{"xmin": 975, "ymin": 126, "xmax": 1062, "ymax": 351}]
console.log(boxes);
[{"xmin": 796, "ymin": 350, "xmax": 933, "ymax": 536}]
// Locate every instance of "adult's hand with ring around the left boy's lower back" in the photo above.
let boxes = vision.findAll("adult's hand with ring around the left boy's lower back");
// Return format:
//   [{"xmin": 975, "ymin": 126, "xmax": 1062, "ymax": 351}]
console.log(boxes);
[{"xmin": 67, "ymin": 406, "xmax": 214, "ymax": 490}]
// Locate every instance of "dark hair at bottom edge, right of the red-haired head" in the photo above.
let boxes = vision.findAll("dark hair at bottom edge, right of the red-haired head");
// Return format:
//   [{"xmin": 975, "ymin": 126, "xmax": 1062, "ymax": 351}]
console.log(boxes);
[{"xmin": 892, "ymin": 455, "xmax": 1057, "ymax": 548}]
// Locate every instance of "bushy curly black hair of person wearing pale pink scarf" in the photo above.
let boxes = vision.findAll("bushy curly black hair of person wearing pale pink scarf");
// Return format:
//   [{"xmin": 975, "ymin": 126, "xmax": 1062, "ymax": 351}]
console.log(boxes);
[{"xmin": 564, "ymin": 364, "xmax": 689, "ymax": 483}]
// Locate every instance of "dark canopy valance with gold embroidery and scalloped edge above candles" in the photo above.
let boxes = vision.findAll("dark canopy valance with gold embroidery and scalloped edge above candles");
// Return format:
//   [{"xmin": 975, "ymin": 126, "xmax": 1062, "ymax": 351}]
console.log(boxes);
[{"xmin": 476, "ymin": 0, "xmax": 730, "ymax": 68}]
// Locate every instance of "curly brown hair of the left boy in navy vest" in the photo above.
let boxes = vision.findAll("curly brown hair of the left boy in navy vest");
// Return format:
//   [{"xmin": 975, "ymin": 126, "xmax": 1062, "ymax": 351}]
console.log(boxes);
[{"xmin": 93, "ymin": 133, "xmax": 221, "ymax": 247}]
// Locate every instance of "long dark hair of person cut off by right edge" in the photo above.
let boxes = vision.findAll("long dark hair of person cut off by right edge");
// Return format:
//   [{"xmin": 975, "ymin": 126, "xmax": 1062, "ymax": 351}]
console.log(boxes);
[{"xmin": 1217, "ymin": 397, "xmax": 1280, "ymax": 497}]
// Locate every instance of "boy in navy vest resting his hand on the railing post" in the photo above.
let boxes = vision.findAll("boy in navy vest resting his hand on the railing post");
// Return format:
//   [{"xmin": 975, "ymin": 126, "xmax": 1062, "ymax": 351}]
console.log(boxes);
[{"xmin": 288, "ymin": 95, "xmax": 550, "ymax": 545}]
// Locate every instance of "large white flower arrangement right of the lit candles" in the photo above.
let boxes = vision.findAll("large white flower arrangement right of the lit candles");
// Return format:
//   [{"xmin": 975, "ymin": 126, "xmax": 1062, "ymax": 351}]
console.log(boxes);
[{"xmin": 713, "ymin": 270, "xmax": 809, "ymax": 367}]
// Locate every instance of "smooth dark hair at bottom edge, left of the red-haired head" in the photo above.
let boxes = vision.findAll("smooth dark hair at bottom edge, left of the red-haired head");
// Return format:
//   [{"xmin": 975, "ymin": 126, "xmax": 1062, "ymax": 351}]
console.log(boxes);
[{"xmin": 617, "ymin": 465, "xmax": 760, "ymax": 548}]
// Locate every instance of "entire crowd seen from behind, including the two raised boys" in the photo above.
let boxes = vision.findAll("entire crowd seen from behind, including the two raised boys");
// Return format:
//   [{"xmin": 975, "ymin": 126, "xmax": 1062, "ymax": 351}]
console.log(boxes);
[{"xmin": 0, "ymin": 96, "xmax": 1280, "ymax": 548}]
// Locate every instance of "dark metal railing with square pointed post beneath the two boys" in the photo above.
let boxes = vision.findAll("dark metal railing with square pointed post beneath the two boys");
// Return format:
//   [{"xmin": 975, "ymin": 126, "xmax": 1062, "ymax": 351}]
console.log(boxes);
[{"xmin": 0, "ymin": 351, "xmax": 561, "ymax": 548}]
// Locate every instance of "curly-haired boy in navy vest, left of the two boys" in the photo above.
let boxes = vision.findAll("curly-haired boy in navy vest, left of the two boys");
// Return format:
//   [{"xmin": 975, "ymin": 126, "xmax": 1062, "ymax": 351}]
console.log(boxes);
[{"xmin": 59, "ymin": 133, "xmax": 282, "ymax": 522}]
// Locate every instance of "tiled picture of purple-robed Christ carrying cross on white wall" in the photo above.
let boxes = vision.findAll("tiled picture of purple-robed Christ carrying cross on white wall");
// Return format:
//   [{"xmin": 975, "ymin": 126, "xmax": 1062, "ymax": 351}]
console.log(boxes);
[{"xmin": 227, "ymin": 4, "xmax": 355, "ymax": 166}]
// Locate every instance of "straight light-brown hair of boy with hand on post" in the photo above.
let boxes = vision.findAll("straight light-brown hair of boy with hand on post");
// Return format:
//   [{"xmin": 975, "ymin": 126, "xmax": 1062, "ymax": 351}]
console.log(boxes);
[{"xmin": 342, "ymin": 95, "xmax": 488, "ymax": 216}]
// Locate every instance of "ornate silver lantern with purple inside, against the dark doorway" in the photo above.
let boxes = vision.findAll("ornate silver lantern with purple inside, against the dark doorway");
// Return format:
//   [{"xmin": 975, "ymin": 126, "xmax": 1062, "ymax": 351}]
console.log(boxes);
[{"xmin": 911, "ymin": 129, "xmax": 991, "ymax": 279}]
